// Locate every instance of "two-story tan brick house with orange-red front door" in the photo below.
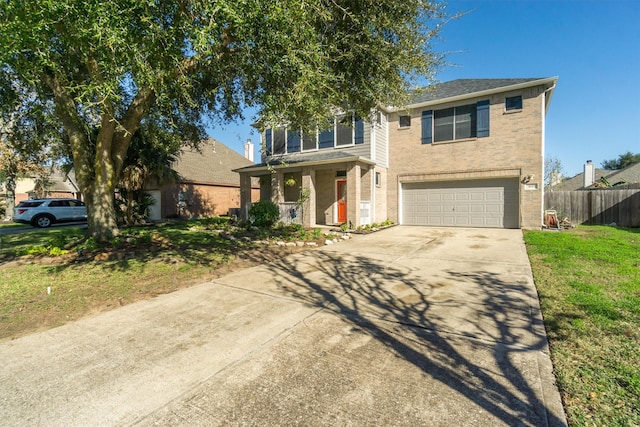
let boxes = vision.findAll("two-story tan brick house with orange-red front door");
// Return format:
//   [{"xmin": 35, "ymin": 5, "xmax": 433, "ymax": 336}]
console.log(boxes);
[{"xmin": 237, "ymin": 77, "xmax": 557, "ymax": 228}]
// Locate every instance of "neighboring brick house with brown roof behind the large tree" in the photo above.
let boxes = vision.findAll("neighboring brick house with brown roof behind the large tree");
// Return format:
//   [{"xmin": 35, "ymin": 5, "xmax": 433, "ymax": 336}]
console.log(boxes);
[{"xmin": 151, "ymin": 139, "xmax": 259, "ymax": 220}]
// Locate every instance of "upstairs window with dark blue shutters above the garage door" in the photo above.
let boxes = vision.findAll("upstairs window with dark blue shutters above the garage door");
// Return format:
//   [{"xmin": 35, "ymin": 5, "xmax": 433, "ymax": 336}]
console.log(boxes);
[{"xmin": 422, "ymin": 101, "xmax": 489, "ymax": 144}]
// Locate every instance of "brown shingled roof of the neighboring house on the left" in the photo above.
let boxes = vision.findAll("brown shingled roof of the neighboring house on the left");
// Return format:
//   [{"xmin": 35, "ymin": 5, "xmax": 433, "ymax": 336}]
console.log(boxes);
[{"xmin": 172, "ymin": 138, "xmax": 253, "ymax": 185}]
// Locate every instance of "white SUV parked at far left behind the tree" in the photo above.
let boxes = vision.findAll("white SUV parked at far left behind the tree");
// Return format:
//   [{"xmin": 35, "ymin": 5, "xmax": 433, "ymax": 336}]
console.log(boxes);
[{"xmin": 13, "ymin": 199, "xmax": 87, "ymax": 228}]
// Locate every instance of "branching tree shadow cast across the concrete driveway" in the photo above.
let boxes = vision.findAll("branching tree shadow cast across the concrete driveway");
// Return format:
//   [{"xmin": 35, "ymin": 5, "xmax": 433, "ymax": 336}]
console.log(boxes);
[{"xmin": 258, "ymin": 251, "xmax": 566, "ymax": 426}]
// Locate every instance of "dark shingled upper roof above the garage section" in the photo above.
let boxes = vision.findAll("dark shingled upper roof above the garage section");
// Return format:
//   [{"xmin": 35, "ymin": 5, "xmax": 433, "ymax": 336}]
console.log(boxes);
[{"xmin": 388, "ymin": 77, "xmax": 558, "ymax": 111}]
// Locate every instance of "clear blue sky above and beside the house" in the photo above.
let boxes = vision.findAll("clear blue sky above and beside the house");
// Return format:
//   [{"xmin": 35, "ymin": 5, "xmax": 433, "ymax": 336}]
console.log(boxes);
[{"xmin": 209, "ymin": 0, "xmax": 640, "ymax": 176}]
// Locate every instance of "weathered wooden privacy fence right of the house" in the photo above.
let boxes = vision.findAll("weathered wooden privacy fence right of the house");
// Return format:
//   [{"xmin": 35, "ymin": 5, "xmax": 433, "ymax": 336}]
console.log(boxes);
[{"xmin": 544, "ymin": 189, "xmax": 640, "ymax": 227}]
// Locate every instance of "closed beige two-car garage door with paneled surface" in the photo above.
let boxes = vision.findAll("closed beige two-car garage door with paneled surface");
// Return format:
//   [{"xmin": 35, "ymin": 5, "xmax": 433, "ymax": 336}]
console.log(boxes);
[{"xmin": 402, "ymin": 178, "xmax": 520, "ymax": 228}]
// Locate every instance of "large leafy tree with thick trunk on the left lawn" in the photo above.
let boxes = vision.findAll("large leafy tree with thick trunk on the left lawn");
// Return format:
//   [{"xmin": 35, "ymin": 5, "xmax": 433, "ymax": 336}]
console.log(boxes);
[{"xmin": 0, "ymin": 0, "xmax": 443, "ymax": 240}]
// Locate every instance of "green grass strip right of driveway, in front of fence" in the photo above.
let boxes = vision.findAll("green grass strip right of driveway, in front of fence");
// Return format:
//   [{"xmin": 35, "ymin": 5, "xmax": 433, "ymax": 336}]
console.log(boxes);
[{"xmin": 524, "ymin": 226, "xmax": 640, "ymax": 426}]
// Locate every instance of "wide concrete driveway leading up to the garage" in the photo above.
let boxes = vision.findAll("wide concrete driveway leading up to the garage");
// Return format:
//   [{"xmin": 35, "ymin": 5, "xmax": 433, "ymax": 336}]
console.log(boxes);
[{"xmin": 0, "ymin": 227, "xmax": 565, "ymax": 426}]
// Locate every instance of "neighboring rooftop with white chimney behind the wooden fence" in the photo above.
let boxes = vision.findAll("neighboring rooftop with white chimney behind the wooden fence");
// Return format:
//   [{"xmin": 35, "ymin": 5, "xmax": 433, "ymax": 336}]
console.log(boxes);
[{"xmin": 551, "ymin": 160, "xmax": 640, "ymax": 191}]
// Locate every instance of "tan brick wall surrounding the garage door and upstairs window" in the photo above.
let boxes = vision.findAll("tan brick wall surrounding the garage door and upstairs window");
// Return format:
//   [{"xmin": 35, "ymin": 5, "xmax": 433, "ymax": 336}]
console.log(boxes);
[{"xmin": 385, "ymin": 86, "xmax": 545, "ymax": 228}]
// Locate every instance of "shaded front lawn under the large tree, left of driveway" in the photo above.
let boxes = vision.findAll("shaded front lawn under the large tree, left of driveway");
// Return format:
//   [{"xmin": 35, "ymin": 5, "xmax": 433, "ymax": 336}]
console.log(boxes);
[{"xmin": 0, "ymin": 218, "xmax": 320, "ymax": 339}]
